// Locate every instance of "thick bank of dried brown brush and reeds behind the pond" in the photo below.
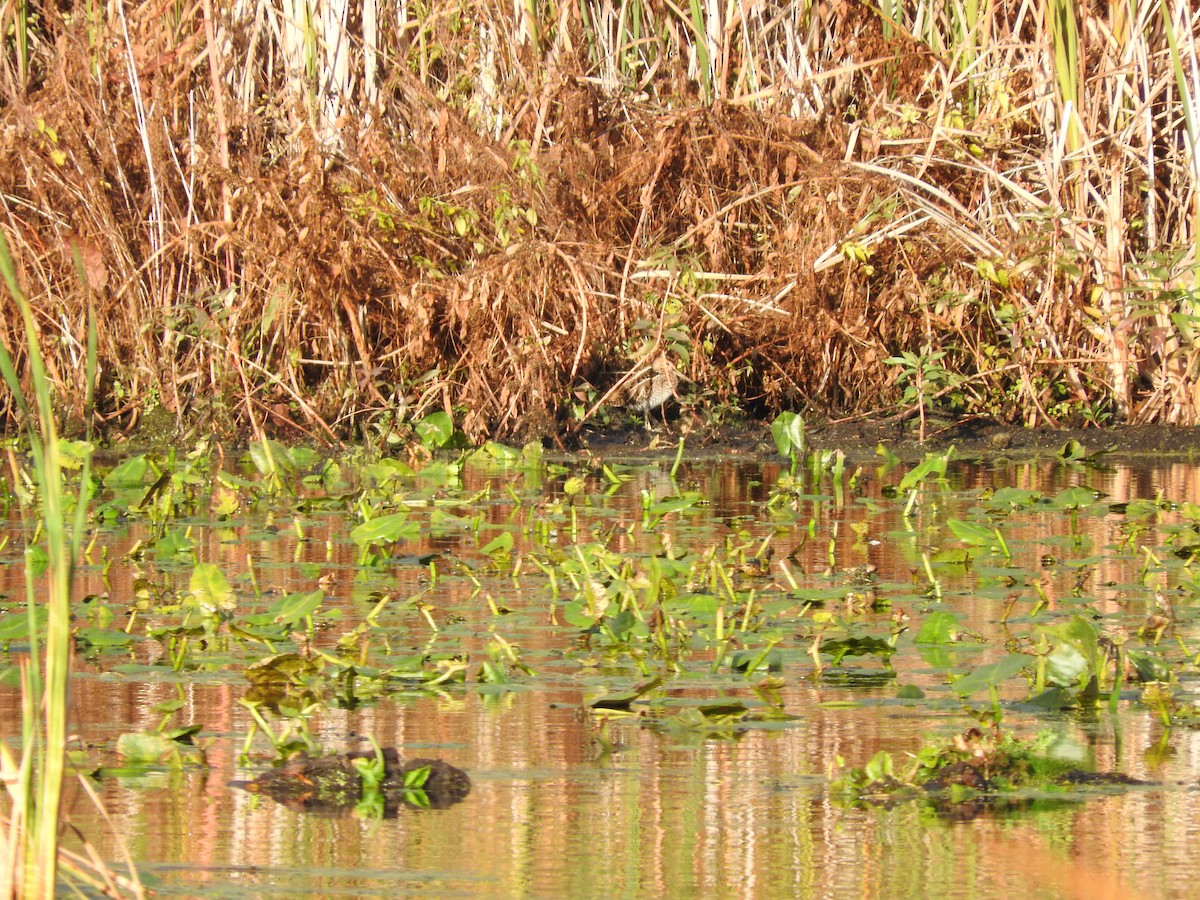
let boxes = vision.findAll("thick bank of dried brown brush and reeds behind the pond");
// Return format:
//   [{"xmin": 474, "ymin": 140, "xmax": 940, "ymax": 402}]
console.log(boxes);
[{"xmin": 0, "ymin": 0, "xmax": 1200, "ymax": 439}]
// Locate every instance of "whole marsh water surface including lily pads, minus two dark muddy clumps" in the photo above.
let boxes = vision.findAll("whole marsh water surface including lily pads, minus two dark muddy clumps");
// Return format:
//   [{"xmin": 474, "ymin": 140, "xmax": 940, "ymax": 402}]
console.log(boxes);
[{"xmin": 0, "ymin": 454, "xmax": 1200, "ymax": 898}]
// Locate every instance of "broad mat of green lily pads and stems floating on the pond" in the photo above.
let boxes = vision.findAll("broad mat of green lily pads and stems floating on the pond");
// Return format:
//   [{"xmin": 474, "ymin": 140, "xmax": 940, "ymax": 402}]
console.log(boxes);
[{"xmin": 7, "ymin": 432, "xmax": 1200, "ymax": 897}]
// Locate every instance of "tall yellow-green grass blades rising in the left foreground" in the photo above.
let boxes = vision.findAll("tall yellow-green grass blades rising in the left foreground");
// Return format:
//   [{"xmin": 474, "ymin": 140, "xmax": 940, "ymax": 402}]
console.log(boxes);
[{"xmin": 0, "ymin": 233, "xmax": 96, "ymax": 898}]
